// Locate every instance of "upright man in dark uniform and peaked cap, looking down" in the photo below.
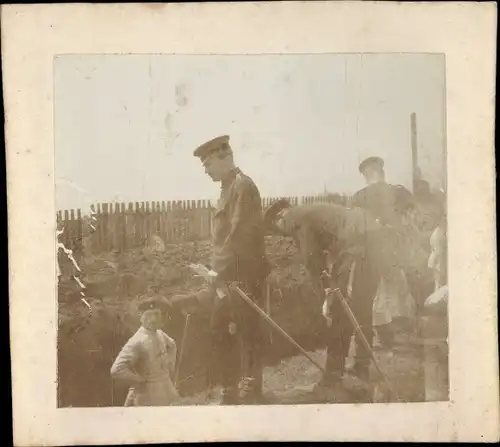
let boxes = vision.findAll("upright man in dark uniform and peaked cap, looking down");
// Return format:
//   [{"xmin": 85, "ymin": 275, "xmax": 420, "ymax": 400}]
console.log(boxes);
[{"xmin": 171, "ymin": 135, "xmax": 270, "ymax": 404}]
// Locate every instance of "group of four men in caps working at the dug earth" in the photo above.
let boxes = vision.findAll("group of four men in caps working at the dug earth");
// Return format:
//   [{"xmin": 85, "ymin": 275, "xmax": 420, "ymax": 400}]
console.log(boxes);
[{"xmin": 111, "ymin": 136, "xmax": 441, "ymax": 406}]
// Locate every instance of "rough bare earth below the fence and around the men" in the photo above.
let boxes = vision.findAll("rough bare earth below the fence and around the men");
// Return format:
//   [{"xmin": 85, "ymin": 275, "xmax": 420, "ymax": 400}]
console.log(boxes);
[{"xmin": 58, "ymin": 237, "xmax": 423, "ymax": 407}]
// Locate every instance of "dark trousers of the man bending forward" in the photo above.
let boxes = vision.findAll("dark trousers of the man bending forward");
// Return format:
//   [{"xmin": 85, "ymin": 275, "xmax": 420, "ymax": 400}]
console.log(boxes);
[{"xmin": 326, "ymin": 250, "xmax": 381, "ymax": 377}]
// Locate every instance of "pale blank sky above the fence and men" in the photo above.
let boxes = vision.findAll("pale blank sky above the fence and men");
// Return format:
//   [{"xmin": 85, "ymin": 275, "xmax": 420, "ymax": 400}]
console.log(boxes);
[{"xmin": 55, "ymin": 54, "xmax": 445, "ymax": 209}]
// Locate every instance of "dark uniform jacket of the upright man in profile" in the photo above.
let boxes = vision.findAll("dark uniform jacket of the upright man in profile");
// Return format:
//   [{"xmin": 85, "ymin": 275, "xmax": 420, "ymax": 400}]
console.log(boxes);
[{"xmin": 211, "ymin": 169, "xmax": 269, "ymax": 281}]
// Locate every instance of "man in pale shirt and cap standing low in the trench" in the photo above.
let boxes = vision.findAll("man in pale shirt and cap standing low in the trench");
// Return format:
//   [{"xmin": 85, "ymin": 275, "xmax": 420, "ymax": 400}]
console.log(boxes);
[{"xmin": 111, "ymin": 297, "xmax": 179, "ymax": 406}]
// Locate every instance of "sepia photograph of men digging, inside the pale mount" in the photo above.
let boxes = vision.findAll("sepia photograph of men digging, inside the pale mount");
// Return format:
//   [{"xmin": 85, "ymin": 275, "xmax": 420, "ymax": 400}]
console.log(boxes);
[{"xmin": 53, "ymin": 53, "xmax": 449, "ymax": 408}]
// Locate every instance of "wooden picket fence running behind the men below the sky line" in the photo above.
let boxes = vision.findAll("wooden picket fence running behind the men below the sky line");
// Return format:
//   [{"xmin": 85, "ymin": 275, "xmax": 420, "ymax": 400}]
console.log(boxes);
[{"xmin": 57, "ymin": 195, "xmax": 347, "ymax": 254}]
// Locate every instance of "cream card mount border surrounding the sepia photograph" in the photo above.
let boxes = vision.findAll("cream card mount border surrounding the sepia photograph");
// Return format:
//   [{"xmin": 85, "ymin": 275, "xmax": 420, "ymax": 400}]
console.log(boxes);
[{"xmin": 2, "ymin": 2, "xmax": 499, "ymax": 446}]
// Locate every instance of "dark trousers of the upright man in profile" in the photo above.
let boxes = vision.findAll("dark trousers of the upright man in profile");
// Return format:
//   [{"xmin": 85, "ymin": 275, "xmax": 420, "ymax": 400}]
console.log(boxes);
[{"xmin": 209, "ymin": 282, "xmax": 266, "ymax": 390}]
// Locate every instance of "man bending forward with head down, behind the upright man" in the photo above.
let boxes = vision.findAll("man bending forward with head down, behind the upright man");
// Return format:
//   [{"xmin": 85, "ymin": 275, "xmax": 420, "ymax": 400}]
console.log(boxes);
[{"xmin": 265, "ymin": 199, "xmax": 384, "ymax": 395}]
